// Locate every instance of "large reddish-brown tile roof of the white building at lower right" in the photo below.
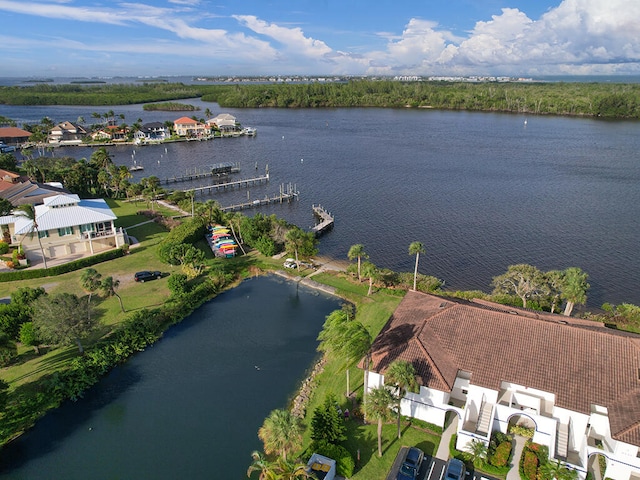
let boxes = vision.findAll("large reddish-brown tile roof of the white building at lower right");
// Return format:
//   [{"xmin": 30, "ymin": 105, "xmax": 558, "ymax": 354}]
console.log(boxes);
[{"xmin": 371, "ymin": 292, "xmax": 640, "ymax": 446}]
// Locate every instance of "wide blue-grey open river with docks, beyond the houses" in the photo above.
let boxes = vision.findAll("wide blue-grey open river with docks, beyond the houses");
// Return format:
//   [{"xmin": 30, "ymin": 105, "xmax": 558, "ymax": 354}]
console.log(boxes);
[{"xmin": 0, "ymin": 100, "xmax": 640, "ymax": 308}]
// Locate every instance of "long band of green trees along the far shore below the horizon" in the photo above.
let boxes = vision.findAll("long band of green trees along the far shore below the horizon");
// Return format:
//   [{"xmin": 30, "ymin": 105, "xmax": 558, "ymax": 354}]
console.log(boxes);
[{"xmin": 0, "ymin": 80, "xmax": 640, "ymax": 118}]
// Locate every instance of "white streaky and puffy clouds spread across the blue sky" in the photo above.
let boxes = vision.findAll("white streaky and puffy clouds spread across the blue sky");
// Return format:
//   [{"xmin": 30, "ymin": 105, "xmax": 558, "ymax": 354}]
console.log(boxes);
[{"xmin": 0, "ymin": 0, "xmax": 640, "ymax": 75}]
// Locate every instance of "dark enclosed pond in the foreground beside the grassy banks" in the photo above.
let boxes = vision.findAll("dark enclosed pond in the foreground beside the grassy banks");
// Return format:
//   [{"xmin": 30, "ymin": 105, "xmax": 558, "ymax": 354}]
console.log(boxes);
[{"xmin": 0, "ymin": 277, "xmax": 339, "ymax": 480}]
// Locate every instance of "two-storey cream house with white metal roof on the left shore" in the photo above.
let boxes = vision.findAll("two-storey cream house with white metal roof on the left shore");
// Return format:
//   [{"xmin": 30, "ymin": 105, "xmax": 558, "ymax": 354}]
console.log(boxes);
[{"xmin": 0, "ymin": 194, "xmax": 127, "ymax": 263}]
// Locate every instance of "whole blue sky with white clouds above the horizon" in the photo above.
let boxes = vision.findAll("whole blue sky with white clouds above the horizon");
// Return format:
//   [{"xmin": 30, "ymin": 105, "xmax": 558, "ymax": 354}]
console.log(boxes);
[{"xmin": 0, "ymin": 0, "xmax": 640, "ymax": 77}]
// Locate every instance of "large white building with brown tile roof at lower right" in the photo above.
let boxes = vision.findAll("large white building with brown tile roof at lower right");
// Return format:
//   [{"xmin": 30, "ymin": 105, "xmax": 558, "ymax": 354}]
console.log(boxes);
[{"xmin": 366, "ymin": 292, "xmax": 640, "ymax": 480}]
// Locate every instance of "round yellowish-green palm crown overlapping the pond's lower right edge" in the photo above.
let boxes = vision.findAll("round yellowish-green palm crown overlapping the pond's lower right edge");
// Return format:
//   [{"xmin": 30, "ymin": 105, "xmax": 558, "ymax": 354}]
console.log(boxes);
[{"xmin": 258, "ymin": 410, "xmax": 304, "ymax": 460}]
